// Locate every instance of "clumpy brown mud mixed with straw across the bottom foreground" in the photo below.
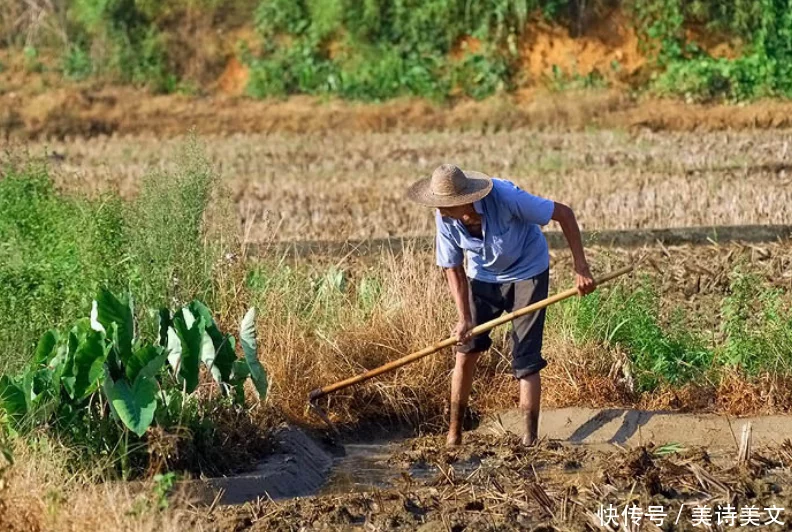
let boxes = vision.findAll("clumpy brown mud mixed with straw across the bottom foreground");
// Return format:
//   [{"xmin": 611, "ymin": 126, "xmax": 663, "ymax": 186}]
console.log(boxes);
[{"xmin": 211, "ymin": 433, "xmax": 792, "ymax": 531}]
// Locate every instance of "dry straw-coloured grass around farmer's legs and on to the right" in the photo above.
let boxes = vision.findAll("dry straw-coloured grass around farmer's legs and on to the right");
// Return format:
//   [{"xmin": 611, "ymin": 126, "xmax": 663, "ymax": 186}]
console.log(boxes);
[{"xmin": 244, "ymin": 239, "xmax": 792, "ymax": 429}]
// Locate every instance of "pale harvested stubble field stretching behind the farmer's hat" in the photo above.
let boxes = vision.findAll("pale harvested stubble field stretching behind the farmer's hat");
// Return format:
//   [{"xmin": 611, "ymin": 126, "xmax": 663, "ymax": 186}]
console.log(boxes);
[{"xmin": 38, "ymin": 130, "xmax": 792, "ymax": 242}]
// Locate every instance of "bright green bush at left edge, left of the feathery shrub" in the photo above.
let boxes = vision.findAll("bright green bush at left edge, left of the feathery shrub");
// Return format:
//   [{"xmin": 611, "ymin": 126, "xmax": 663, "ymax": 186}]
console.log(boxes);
[{"xmin": 0, "ymin": 161, "xmax": 125, "ymax": 370}]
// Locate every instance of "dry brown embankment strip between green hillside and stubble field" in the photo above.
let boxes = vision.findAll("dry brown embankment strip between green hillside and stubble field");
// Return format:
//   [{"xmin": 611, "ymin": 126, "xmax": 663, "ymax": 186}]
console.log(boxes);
[{"xmin": 6, "ymin": 87, "xmax": 792, "ymax": 142}]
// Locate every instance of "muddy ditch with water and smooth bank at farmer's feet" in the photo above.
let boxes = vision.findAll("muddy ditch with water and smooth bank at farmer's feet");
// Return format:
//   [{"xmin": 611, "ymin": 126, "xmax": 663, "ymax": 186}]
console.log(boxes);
[{"xmin": 187, "ymin": 407, "xmax": 792, "ymax": 508}]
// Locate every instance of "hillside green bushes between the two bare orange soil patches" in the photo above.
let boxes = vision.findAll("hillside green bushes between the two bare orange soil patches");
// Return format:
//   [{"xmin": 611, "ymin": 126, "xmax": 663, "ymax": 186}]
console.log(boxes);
[{"xmin": 248, "ymin": 0, "xmax": 566, "ymax": 101}]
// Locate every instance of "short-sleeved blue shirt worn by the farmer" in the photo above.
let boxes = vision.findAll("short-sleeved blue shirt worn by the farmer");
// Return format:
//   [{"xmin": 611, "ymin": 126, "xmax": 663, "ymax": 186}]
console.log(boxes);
[{"xmin": 435, "ymin": 178, "xmax": 555, "ymax": 283}]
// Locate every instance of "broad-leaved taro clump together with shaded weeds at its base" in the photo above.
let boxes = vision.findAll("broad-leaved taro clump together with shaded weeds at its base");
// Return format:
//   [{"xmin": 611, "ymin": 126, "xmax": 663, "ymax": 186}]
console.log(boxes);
[{"xmin": 0, "ymin": 290, "xmax": 267, "ymax": 478}]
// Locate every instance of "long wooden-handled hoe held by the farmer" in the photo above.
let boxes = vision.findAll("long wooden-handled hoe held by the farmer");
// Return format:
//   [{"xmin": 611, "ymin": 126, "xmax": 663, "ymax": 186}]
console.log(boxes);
[{"xmin": 308, "ymin": 265, "xmax": 635, "ymax": 434}]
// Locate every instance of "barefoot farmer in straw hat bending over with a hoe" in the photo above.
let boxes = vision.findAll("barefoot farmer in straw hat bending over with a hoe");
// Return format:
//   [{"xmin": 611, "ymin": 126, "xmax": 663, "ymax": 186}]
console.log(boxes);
[{"xmin": 407, "ymin": 164, "xmax": 596, "ymax": 446}]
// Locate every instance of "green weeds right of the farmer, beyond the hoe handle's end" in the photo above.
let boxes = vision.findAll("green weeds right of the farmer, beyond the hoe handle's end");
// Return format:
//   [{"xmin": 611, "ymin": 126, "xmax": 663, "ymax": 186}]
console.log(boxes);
[{"xmin": 551, "ymin": 269, "xmax": 792, "ymax": 391}]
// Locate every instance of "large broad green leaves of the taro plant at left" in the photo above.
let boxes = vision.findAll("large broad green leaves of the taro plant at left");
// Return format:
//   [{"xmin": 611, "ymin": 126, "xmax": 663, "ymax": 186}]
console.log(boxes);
[{"xmin": 0, "ymin": 290, "xmax": 267, "ymax": 436}]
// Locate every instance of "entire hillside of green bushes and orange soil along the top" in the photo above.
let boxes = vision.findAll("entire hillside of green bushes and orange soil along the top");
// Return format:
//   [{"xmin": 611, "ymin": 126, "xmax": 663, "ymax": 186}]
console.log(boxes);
[{"xmin": 0, "ymin": 0, "xmax": 792, "ymax": 101}]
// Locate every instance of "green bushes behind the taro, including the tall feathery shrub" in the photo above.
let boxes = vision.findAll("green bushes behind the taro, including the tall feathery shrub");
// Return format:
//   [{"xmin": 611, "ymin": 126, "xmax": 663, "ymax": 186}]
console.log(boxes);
[{"xmin": 0, "ymin": 142, "xmax": 233, "ymax": 371}]
